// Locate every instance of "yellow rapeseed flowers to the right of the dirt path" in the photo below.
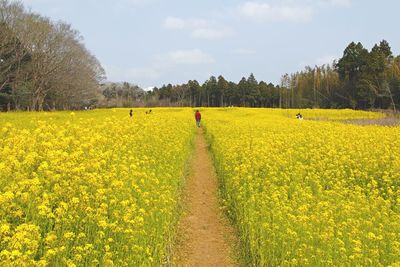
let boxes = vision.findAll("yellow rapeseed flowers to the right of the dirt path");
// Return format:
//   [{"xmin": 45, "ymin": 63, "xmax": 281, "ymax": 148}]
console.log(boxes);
[{"xmin": 203, "ymin": 108, "xmax": 400, "ymax": 266}]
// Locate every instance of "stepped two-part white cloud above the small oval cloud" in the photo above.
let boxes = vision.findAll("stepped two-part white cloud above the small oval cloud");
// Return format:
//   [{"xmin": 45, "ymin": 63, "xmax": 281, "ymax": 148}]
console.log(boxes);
[{"xmin": 163, "ymin": 16, "xmax": 233, "ymax": 40}]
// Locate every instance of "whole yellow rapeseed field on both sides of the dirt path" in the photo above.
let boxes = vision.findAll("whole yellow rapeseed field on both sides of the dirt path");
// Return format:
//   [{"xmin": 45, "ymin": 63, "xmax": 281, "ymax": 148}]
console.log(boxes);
[{"xmin": 0, "ymin": 108, "xmax": 400, "ymax": 266}]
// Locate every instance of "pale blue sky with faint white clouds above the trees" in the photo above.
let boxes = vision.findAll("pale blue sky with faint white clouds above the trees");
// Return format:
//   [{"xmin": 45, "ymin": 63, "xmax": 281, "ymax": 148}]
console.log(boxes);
[{"xmin": 16, "ymin": 0, "xmax": 400, "ymax": 88}]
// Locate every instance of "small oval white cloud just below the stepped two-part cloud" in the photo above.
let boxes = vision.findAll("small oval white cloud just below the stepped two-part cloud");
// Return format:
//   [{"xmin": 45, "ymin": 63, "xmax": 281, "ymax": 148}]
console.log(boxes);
[{"xmin": 165, "ymin": 49, "xmax": 215, "ymax": 65}]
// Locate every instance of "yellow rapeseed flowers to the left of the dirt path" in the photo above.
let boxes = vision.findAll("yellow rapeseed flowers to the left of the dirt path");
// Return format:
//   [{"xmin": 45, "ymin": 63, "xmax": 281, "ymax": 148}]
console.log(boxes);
[{"xmin": 0, "ymin": 109, "xmax": 195, "ymax": 266}]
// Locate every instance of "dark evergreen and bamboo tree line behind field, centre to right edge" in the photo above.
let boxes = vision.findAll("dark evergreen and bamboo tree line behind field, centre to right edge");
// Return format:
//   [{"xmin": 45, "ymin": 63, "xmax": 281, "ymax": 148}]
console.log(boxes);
[{"xmin": 146, "ymin": 40, "xmax": 400, "ymax": 110}]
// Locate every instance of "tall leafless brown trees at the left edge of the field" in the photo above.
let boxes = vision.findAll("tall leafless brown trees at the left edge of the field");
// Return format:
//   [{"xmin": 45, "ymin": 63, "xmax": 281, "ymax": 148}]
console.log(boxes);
[{"xmin": 0, "ymin": 0, "xmax": 104, "ymax": 111}]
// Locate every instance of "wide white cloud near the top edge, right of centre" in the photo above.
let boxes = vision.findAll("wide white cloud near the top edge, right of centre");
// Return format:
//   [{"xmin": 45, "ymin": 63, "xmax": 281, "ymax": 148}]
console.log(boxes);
[{"xmin": 238, "ymin": 1, "xmax": 314, "ymax": 22}]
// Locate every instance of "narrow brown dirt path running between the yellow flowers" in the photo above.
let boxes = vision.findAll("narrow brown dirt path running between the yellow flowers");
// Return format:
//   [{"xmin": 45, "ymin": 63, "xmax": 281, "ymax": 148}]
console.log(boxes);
[{"xmin": 173, "ymin": 129, "xmax": 236, "ymax": 266}]
